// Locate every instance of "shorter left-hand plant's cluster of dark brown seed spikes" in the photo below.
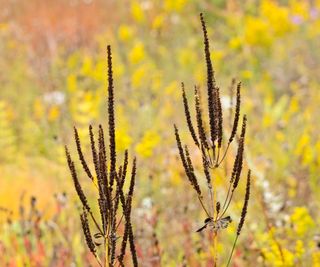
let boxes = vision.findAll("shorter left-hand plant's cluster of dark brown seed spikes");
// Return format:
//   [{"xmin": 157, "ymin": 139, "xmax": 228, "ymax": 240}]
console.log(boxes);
[{"xmin": 66, "ymin": 46, "xmax": 138, "ymax": 267}]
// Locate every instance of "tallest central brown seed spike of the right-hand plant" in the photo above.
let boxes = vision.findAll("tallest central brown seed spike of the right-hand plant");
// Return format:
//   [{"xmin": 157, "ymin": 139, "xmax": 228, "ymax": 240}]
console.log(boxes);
[{"xmin": 200, "ymin": 13, "xmax": 217, "ymax": 147}]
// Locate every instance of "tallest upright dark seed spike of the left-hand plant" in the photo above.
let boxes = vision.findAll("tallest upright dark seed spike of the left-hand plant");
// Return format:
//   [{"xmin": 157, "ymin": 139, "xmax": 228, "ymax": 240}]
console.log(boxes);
[{"xmin": 107, "ymin": 45, "xmax": 116, "ymax": 187}]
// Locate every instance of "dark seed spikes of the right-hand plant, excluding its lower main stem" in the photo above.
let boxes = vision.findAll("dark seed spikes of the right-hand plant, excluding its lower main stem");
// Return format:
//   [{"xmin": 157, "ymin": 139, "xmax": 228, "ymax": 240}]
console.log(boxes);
[{"xmin": 174, "ymin": 14, "xmax": 250, "ymax": 267}]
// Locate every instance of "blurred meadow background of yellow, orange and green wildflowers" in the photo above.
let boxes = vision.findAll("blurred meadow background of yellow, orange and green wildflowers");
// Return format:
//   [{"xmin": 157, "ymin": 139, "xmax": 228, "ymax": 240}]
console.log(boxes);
[{"xmin": 0, "ymin": 0, "xmax": 320, "ymax": 267}]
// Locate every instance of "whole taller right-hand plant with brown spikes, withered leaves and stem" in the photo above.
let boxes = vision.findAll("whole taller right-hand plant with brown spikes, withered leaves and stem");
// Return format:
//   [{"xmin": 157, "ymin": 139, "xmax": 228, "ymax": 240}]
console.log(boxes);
[{"xmin": 174, "ymin": 14, "xmax": 251, "ymax": 266}]
